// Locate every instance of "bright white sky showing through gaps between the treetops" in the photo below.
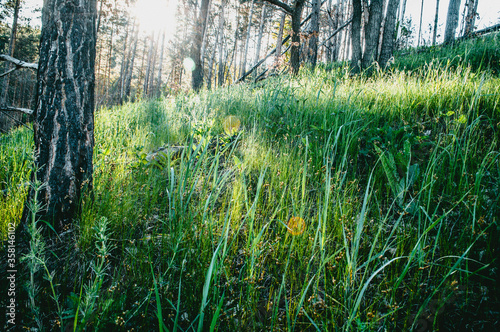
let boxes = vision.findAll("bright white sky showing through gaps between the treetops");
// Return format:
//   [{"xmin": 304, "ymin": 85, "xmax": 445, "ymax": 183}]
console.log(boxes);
[{"xmin": 10, "ymin": 0, "xmax": 500, "ymax": 41}]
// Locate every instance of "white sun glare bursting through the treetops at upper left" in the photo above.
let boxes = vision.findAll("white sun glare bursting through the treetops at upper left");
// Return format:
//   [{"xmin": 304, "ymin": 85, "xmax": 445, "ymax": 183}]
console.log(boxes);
[{"xmin": 131, "ymin": 0, "xmax": 178, "ymax": 41}]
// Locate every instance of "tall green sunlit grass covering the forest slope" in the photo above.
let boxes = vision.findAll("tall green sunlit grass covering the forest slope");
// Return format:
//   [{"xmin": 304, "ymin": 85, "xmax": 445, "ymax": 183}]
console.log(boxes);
[{"xmin": 0, "ymin": 35, "xmax": 500, "ymax": 331}]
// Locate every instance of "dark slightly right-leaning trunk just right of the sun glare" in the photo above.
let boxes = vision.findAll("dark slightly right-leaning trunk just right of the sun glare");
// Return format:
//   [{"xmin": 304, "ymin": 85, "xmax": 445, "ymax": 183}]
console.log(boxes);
[{"xmin": 191, "ymin": 0, "xmax": 210, "ymax": 91}]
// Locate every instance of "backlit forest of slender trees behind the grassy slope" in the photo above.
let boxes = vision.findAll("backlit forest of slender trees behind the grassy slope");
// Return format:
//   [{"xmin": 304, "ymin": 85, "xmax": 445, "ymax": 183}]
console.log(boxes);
[{"xmin": 0, "ymin": 0, "xmax": 479, "ymax": 131}]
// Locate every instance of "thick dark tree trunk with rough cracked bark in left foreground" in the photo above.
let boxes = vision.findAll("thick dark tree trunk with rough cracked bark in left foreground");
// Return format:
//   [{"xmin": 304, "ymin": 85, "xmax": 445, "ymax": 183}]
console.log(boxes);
[{"xmin": 22, "ymin": 0, "xmax": 97, "ymax": 232}]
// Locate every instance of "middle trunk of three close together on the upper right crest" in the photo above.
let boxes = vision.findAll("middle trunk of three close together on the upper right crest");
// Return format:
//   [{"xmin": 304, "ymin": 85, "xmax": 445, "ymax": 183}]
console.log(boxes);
[{"xmin": 363, "ymin": 0, "xmax": 384, "ymax": 68}]
